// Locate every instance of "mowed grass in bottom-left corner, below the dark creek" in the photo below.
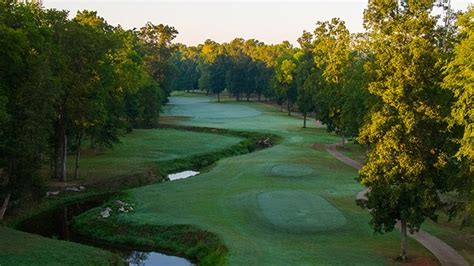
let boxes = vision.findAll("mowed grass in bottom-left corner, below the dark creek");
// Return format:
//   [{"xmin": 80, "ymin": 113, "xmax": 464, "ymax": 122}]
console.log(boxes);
[{"xmin": 0, "ymin": 226, "xmax": 123, "ymax": 266}]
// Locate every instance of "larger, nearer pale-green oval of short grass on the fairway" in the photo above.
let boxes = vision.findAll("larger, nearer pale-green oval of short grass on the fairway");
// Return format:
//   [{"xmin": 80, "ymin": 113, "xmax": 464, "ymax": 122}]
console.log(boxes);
[{"xmin": 257, "ymin": 190, "xmax": 347, "ymax": 233}]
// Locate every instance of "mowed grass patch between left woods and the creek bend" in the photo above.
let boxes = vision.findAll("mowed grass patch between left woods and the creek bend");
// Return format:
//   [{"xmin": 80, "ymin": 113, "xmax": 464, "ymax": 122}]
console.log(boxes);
[{"xmin": 60, "ymin": 129, "xmax": 241, "ymax": 181}]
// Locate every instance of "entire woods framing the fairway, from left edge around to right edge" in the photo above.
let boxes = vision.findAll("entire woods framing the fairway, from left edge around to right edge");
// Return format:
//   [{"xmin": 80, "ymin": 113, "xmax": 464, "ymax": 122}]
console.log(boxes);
[{"xmin": 0, "ymin": 0, "xmax": 474, "ymax": 259}]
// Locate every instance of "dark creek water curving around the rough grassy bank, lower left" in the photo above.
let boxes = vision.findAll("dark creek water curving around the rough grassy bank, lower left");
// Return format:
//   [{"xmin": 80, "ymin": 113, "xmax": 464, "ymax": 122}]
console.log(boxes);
[{"xmin": 20, "ymin": 197, "xmax": 194, "ymax": 266}]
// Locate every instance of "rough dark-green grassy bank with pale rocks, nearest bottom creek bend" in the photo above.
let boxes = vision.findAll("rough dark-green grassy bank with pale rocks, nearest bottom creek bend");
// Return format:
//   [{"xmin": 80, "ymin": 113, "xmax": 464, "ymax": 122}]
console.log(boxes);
[{"xmin": 73, "ymin": 197, "xmax": 228, "ymax": 265}]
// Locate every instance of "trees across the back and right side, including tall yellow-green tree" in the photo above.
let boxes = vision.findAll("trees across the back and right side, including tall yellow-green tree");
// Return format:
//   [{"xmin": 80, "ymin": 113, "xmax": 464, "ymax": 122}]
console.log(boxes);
[{"xmin": 168, "ymin": 0, "xmax": 474, "ymax": 260}]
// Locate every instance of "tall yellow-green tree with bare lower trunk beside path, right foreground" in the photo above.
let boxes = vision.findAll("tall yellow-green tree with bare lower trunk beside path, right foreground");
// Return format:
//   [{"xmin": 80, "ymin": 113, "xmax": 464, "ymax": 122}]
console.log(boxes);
[{"xmin": 359, "ymin": 0, "xmax": 451, "ymax": 261}]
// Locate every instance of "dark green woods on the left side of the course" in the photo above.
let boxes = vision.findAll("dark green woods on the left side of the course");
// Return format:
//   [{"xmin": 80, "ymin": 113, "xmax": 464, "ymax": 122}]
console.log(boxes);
[{"xmin": 0, "ymin": 1, "xmax": 177, "ymax": 207}]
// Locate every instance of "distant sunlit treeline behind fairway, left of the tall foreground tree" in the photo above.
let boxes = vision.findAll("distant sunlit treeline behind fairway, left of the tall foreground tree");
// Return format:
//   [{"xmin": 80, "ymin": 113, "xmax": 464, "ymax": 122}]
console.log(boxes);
[{"xmin": 172, "ymin": 19, "xmax": 373, "ymax": 138}]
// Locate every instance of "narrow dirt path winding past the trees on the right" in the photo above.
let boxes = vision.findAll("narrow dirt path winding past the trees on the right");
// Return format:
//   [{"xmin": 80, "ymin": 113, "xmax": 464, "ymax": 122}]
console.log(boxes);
[{"xmin": 325, "ymin": 144, "xmax": 469, "ymax": 266}]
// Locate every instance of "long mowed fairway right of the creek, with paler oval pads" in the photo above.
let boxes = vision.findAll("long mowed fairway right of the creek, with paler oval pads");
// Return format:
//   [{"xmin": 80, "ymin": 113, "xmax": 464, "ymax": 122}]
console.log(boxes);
[{"xmin": 76, "ymin": 94, "xmax": 436, "ymax": 265}]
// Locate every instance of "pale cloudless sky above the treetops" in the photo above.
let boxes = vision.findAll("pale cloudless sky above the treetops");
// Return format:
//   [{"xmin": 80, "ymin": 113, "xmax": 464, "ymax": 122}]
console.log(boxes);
[{"xmin": 43, "ymin": 0, "xmax": 473, "ymax": 45}]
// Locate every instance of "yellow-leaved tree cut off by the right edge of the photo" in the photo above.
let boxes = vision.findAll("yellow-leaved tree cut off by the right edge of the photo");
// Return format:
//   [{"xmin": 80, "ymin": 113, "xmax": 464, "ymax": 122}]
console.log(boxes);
[{"xmin": 443, "ymin": 6, "xmax": 474, "ymax": 222}]
